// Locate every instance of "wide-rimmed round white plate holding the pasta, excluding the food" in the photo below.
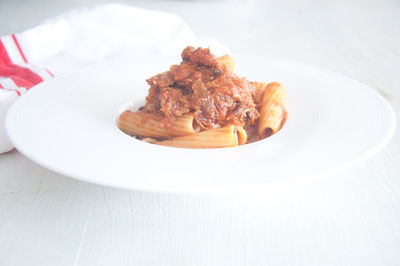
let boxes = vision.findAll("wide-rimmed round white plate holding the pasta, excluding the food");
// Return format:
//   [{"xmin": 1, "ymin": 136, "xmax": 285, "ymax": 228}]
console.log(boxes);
[{"xmin": 6, "ymin": 56, "xmax": 395, "ymax": 192}]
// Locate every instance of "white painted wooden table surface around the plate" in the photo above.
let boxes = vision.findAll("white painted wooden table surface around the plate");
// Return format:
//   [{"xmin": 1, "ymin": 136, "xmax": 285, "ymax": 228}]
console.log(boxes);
[{"xmin": 0, "ymin": 0, "xmax": 400, "ymax": 266}]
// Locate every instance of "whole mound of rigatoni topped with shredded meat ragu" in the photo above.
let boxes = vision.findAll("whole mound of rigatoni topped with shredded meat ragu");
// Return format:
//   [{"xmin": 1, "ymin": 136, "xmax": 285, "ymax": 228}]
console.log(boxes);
[{"xmin": 118, "ymin": 46, "xmax": 287, "ymax": 148}]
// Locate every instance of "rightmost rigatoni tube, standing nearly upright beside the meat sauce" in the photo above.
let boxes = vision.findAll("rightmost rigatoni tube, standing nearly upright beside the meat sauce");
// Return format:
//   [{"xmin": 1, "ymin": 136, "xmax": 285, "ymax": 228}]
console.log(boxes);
[{"xmin": 258, "ymin": 82, "xmax": 286, "ymax": 138}]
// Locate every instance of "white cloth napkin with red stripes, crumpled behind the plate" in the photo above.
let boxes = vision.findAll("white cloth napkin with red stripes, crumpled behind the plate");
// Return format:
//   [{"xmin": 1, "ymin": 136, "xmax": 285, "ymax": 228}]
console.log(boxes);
[{"xmin": 0, "ymin": 4, "xmax": 226, "ymax": 153}]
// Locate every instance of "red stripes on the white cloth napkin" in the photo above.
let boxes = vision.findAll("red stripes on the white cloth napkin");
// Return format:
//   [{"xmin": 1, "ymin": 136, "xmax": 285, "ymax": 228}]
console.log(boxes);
[{"xmin": 0, "ymin": 36, "xmax": 43, "ymax": 89}]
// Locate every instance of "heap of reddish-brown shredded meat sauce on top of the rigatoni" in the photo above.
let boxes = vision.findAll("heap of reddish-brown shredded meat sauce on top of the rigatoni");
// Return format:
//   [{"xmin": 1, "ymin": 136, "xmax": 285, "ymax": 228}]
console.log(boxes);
[{"xmin": 141, "ymin": 46, "xmax": 259, "ymax": 129}]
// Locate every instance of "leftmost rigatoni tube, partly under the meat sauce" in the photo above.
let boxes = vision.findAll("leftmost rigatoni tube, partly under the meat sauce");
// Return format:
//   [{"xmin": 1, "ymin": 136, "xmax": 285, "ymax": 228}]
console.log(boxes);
[{"xmin": 118, "ymin": 110, "xmax": 196, "ymax": 138}]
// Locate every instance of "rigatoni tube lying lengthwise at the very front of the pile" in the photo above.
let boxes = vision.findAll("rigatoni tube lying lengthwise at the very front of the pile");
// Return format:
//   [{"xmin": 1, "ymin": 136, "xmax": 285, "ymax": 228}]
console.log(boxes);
[{"xmin": 156, "ymin": 125, "xmax": 247, "ymax": 149}]
